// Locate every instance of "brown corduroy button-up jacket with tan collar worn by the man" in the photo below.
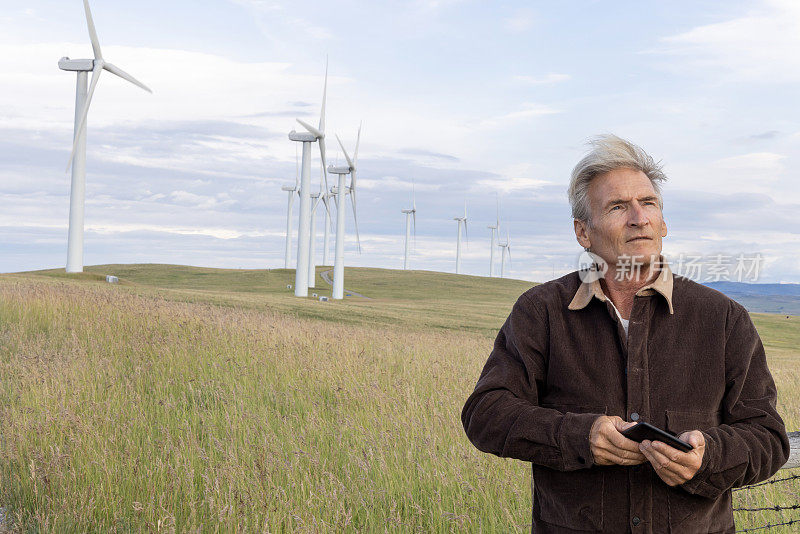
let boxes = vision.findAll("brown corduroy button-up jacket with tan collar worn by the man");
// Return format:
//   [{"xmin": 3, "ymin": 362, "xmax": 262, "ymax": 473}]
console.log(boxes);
[{"xmin": 461, "ymin": 266, "xmax": 789, "ymax": 533}]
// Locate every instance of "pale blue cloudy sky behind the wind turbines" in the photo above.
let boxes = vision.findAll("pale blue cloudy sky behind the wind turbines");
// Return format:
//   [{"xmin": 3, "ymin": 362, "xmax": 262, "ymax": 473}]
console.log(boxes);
[{"xmin": 0, "ymin": 0, "xmax": 800, "ymax": 283}]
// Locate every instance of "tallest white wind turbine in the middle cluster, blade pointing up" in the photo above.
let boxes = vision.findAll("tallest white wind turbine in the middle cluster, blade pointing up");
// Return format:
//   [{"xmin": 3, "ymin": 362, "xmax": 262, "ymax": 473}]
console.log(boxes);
[{"xmin": 289, "ymin": 60, "xmax": 328, "ymax": 297}]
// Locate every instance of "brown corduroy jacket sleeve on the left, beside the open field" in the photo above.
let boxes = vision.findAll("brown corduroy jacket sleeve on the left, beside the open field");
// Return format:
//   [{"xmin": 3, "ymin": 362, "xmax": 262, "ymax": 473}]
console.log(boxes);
[{"xmin": 461, "ymin": 295, "xmax": 602, "ymax": 471}]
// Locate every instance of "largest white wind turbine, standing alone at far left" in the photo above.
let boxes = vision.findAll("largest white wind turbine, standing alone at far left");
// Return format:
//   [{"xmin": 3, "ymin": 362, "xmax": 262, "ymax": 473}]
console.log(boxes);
[{"xmin": 58, "ymin": 0, "xmax": 152, "ymax": 273}]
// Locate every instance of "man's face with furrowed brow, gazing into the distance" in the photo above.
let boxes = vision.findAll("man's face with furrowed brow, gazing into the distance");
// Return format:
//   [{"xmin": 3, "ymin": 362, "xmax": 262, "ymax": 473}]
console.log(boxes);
[{"xmin": 575, "ymin": 168, "xmax": 667, "ymax": 268}]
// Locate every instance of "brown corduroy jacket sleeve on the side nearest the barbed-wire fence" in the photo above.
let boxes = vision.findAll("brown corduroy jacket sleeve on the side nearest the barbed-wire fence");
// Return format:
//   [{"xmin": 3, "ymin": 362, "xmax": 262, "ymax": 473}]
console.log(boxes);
[{"xmin": 682, "ymin": 305, "xmax": 789, "ymax": 498}]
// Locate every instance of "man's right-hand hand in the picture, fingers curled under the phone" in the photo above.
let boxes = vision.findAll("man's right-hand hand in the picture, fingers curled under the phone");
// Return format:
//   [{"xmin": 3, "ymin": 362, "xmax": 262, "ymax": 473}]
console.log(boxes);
[{"xmin": 639, "ymin": 430, "xmax": 706, "ymax": 486}]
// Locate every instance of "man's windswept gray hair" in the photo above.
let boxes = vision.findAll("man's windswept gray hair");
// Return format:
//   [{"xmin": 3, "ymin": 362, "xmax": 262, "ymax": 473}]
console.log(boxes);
[{"xmin": 567, "ymin": 134, "xmax": 667, "ymax": 225}]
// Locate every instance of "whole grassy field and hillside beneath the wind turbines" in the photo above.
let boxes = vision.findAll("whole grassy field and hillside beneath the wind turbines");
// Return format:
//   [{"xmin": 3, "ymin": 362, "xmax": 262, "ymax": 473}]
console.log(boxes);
[{"xmin": 0, "ymin": 265, "xmax": 800, "ymax": 532}]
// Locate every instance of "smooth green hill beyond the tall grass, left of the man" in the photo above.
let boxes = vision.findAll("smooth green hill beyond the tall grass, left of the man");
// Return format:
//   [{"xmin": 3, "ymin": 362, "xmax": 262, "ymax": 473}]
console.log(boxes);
[{"xmin": 25, "ymin": 264, "xmax": 534, "ymax": 334}]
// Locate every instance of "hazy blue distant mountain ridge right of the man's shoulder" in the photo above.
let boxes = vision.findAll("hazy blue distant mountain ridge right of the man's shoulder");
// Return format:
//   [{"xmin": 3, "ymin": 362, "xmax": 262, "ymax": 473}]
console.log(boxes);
[{"xmin": 704, "ymin": 281, "xmax": 800, "ymax": 315}]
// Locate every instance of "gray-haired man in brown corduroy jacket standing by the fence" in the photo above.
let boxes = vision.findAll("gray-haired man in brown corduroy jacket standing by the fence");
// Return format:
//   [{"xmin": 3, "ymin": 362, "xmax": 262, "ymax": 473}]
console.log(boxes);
[{"xmin": 462, "ymin": 135, "xmax": 789, "ymax": 533}]
